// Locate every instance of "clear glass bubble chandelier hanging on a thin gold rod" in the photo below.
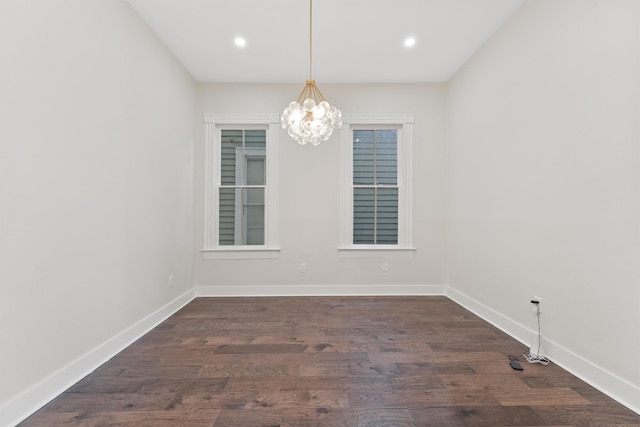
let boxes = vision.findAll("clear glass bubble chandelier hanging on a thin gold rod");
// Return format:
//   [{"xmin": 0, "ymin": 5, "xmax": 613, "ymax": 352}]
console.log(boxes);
[{"xmin": 280, "ymin": 0, "xmax": 342, "ymax": 145}]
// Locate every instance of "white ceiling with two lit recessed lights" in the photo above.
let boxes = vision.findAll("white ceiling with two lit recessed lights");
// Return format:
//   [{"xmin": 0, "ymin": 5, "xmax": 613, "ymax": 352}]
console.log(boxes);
[{"xmin": 129, "ymin": 0, "xmax": 525, "ymax": 84}]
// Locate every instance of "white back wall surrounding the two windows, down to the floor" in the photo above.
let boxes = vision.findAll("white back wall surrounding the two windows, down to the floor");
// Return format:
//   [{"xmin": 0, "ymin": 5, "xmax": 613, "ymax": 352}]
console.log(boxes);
[{"xmin": 195, "ymin": 82, "xmax": 446, "ymax": 295}]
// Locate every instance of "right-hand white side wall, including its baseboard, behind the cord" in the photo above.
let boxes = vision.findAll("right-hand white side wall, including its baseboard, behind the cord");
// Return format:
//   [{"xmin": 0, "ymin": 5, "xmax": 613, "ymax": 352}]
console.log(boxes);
[{"xmin": 447, "ymin": 0, "xmax": 640, "ymax": 411}]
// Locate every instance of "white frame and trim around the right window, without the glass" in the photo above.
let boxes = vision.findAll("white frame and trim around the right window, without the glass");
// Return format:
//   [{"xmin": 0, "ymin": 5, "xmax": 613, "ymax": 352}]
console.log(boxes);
[{"xmin": 338, "ymin": 113, "xmax": 415, "ymax": 258}]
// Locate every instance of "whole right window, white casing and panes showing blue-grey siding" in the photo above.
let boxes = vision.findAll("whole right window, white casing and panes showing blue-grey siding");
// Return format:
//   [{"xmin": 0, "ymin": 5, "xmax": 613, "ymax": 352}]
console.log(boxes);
[{"xmin": 339, "ymin": 114, "xmax": 413, "ymax": 256}]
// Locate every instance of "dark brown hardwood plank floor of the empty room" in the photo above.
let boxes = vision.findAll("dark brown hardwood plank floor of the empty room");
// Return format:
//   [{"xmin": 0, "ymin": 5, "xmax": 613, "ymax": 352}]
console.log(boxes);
[{"xmin": 20, "ymin": 297, "xmax": 640, "ymax": 427}]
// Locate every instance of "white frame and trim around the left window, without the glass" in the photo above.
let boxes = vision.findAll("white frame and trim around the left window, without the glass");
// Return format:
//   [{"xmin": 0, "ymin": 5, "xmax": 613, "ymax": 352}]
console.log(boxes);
[{"xmin": 202, "ymin": 113, "xmax": 280, "ymax": 259}]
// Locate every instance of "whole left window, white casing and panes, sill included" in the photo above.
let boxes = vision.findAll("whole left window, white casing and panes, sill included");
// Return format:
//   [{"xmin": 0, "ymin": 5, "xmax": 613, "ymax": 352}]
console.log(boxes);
[{"xmin": 203, "ymin": 114, "xmax": 278, "ymax": 259}]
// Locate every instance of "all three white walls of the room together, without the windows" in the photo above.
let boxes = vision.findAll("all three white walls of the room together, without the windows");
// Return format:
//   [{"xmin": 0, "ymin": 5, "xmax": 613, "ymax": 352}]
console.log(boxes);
[{"xmin": 5, "ymin": 0, "xmax": 640, "ymax": 425}]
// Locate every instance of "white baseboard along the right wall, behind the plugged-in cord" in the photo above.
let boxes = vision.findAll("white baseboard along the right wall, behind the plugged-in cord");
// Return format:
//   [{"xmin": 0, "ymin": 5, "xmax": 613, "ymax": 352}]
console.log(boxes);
[{"xmin": 446, "ymin": 287, "xmax": 640, "ymax": 414}]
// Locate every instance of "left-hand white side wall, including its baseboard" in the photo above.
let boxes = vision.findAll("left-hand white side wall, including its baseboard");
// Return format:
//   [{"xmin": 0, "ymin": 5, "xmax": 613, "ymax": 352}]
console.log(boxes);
[{"xmin": 0, "ymin": 0, "xmax": 195, "ymax": 425}]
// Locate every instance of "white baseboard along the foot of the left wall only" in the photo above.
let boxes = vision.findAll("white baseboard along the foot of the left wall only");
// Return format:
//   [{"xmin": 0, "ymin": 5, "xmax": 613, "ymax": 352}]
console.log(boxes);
[{"xmin": 0, "ymin": 289, "xmax": 195, "ymax": 426}]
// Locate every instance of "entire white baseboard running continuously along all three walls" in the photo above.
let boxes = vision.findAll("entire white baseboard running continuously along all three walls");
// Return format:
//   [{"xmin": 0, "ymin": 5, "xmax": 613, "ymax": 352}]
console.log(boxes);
[{"xmin": 6, "ymin": 284, "xmax": 640, "ymax": 426}]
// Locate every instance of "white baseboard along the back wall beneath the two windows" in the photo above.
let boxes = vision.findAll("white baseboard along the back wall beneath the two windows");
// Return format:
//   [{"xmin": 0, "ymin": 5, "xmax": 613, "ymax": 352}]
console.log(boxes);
[{"xmin": 196, "ymin": 284, "xmax": 447, "ymax": 297}]
